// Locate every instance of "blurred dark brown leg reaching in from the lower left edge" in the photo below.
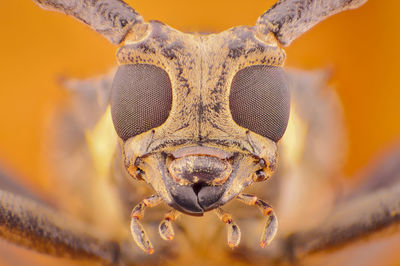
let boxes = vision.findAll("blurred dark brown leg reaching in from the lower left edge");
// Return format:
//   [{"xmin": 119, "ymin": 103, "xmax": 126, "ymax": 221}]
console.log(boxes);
[{"xmin": 0, "ymin": 189, "xmax": 119, "ymax": 265}]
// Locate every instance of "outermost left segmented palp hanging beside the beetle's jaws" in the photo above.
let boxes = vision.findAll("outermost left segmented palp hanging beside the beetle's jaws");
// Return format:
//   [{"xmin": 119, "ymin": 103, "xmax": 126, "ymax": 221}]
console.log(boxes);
[{"xmin": 131, "ymin": 195, "xmax": 162, "ymax": 254}]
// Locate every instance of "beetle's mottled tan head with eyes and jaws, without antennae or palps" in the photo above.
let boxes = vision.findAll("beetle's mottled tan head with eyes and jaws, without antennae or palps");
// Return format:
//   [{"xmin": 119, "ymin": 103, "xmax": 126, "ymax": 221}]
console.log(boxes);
[{"xmin": 111, "ymin": 22, "xmax": 290, "ymax": 215}]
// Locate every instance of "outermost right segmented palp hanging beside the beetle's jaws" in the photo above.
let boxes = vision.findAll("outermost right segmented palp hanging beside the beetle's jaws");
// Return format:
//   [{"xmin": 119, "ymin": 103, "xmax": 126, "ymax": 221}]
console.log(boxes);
[{"xmin": 237, "ymin": 194, "xmax": 278, "ymax": 248}]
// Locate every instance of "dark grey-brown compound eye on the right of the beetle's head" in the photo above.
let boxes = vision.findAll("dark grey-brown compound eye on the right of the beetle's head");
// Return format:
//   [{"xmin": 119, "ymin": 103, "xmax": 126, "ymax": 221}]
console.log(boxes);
[{"xmin": 229, "ymin": 65, "xmax": 290, "ymax": 142}]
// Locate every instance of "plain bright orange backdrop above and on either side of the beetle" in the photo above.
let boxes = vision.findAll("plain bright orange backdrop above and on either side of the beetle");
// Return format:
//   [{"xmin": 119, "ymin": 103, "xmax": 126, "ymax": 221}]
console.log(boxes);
[{"xmin": 0, "ymin": 0, "xmax": 400, "ymax": 263}]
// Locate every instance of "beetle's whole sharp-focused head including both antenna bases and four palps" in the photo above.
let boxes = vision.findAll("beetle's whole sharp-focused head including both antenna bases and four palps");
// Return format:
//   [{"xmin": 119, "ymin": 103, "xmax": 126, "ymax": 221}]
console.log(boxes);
[{"xmin": 32, "ymin": 0, "xmax": 365, "ymax": 253}]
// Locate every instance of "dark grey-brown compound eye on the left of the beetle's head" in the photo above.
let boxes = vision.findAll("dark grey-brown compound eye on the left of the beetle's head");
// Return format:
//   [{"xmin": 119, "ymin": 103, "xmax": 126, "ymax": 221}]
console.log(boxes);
[{"xmin": 111, "ymin": 64, "xmax": 172, "ymax": 140}]
